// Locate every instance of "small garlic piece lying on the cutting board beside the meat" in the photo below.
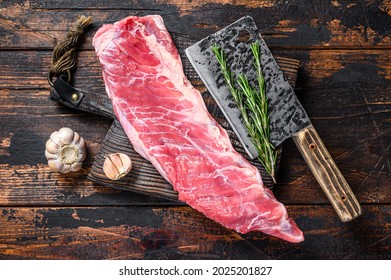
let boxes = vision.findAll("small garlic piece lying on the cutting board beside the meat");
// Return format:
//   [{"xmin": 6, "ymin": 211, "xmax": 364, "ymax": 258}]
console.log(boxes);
[{"xmin": 103, "ymin": 153, "xmax": 132, "ymax": 180}]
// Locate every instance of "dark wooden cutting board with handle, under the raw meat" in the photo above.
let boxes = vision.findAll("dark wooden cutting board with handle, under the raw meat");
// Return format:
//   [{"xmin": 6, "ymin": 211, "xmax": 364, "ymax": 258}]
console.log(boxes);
[{"xmin": 50, "ymin": 57, "xmax": 300, "ymax": 201}]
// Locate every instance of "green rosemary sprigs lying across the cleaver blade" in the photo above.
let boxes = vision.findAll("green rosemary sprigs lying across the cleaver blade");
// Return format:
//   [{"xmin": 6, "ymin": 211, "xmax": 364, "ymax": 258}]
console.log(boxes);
[{"xmin": 212, "ymin": 41, "xmax": 277, "ymax": 183}]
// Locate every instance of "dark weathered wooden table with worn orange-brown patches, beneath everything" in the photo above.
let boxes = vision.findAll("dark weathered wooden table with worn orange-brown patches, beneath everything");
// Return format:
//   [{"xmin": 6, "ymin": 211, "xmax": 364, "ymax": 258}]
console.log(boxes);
[{"xmin": 0, "ymin": 0, "xmax": 391, "ymax": 259}]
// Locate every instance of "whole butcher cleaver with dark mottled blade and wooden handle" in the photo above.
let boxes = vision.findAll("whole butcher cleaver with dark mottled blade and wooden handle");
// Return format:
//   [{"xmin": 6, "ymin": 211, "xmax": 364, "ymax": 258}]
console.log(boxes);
[{"xmin": 185, "ymin": 16, "xmax": 361, "ymax": 222}]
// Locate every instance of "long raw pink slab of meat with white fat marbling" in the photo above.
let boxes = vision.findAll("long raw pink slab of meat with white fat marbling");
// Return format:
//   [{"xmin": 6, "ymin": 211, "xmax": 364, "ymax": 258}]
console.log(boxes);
[{"xmin": 93, "ymin": 15, "xmax": 304, "ymax": 242}]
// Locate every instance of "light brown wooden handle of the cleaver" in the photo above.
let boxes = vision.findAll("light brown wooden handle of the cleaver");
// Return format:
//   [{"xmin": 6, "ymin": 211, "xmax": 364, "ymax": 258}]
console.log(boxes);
[{"xmin": 293, "ymin": 125, "xmax": 361, "ymax": 222}]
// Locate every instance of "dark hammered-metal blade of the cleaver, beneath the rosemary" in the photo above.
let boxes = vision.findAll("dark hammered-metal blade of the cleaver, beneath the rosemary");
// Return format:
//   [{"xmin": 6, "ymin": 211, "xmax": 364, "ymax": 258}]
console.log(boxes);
[{"xmin": 186, "ymin": 16, "xmax": 311, "ymax": 149}]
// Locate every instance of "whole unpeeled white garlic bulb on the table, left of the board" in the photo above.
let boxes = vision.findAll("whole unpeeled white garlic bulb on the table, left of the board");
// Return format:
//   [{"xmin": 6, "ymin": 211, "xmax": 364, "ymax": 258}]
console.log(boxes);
[{"xmin": 45, "ymin": 127, "xmax": 87, "ymax": 173}]
